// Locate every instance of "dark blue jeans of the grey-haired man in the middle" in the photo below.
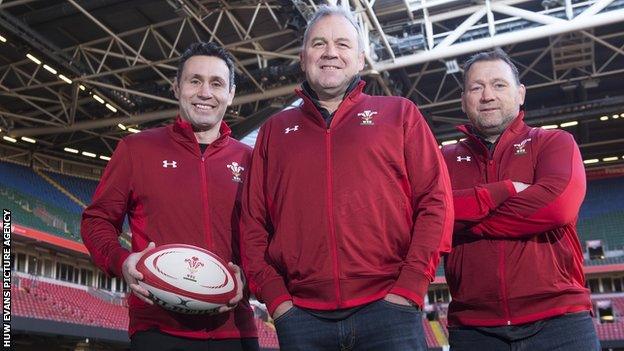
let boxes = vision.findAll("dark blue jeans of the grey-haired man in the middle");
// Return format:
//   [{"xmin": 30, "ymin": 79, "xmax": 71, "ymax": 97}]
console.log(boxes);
[{"xmin": 275, "ymin": 300, "xmax": 427, "ymax": 351}]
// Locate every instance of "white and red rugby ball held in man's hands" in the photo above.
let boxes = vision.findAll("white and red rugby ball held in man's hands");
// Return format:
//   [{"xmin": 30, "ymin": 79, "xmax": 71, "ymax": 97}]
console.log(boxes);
[{"xmin": 136, "ymin": 244, "xmax": 238, "ymax": 314}]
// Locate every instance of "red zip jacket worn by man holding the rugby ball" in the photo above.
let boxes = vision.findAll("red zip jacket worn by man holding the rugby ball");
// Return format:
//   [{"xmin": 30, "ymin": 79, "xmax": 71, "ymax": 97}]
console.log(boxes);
[{"xmin": 81, "ymin": 118, "xmax": 257, "ymax": 339}]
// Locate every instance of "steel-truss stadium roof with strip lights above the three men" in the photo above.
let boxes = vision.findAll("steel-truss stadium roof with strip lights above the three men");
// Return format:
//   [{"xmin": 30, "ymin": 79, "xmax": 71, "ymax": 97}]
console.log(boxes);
[{"xmin": 0, "ymin": 0, "xmax": 624, "ymax": 176}]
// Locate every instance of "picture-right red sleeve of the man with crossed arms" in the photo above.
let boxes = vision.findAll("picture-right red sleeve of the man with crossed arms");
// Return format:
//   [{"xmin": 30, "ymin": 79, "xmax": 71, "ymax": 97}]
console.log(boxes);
[{"xmin": 470, "ymin": 131, "xmax": 586, "ymax": 239}]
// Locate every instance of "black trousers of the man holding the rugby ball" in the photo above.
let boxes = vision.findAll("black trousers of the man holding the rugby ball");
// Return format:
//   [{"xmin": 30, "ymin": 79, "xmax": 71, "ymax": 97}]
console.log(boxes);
[{"xmin": 130, "ymin": 329, "xmax": 260, "ymax": 351}]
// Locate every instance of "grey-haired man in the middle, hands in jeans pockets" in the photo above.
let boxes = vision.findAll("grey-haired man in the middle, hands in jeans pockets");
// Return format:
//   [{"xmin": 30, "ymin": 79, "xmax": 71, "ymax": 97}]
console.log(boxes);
[{"xmin": 243, "ymin": 6, "xmax": 453, "ymax": 351}]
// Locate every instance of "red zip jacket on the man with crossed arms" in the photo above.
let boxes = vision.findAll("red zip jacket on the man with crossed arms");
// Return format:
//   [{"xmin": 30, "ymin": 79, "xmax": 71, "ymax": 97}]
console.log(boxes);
[{"xmin": 442, "ymin": 112, "xmax": 591, "ymax": 326}]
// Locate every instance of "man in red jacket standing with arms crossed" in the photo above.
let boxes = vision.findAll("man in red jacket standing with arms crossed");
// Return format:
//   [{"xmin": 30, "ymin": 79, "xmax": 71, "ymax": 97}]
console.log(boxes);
[{"xmin": 442, "ymin": 49, "xmax": 600, "ymax": 351}]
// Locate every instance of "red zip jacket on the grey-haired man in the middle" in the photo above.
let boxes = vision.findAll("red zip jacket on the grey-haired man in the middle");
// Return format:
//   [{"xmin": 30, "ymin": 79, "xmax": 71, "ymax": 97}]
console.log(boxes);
[{"xmin": 243, "ymin": 82, "xmax": 453, "ymax": 313}]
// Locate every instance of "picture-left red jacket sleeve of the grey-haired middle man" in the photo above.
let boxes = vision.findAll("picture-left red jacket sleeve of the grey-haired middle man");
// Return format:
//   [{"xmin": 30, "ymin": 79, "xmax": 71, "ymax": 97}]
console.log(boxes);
[{"xmin": 241, "ymin": 124, "xmax": 292, "ymax": 314}]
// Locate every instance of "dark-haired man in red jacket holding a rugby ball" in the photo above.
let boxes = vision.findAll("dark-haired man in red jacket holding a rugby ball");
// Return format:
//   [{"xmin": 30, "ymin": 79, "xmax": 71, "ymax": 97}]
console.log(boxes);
[{"xmin": 81, "ymin": 43, "xmax": 258, "ymax": 350}]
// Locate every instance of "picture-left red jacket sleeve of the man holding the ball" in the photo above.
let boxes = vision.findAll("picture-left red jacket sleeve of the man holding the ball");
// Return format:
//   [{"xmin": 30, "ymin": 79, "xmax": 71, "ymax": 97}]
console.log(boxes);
[{"xmin": 80, "ymin": 140, "xmax": 132, "ymax": 276}]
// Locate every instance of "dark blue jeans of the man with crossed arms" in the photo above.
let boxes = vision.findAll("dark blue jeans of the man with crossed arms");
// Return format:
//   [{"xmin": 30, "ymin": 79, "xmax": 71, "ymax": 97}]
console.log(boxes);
[{"xmin": 449, "ymin": 312, "xmax": 600, "ymax": 351}]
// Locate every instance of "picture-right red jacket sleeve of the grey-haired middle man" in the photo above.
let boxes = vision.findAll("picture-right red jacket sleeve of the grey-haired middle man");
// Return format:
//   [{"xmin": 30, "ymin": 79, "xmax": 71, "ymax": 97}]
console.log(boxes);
[{"xmin": 390, "ymin": 103, "xmax": 453, "ymax": 305}]
